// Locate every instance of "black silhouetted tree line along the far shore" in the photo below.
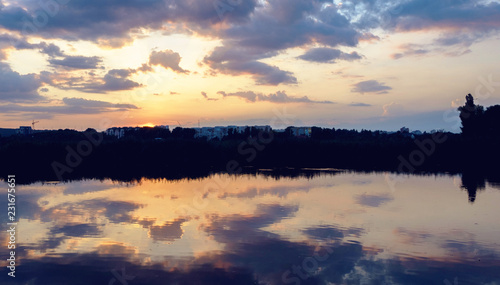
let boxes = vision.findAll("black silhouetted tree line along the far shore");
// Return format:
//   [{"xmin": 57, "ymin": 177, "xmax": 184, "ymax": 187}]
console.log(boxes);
[{"xmin": 0, "ymin": 94, "xmax": 500, "ymax": 192}]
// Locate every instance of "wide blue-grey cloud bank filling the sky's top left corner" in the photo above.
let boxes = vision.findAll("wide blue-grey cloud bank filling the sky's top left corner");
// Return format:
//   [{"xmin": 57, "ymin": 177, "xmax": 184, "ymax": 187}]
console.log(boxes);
[{"xmin": 0, "ymin": 0, "xmax": 258, "ymax": 47}]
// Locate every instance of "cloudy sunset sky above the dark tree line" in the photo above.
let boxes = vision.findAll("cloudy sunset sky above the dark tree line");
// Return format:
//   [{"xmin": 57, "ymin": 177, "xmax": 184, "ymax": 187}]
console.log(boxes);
[{"xmin": 0, "ymin": 0, "xmax": 500, "ymax": 132}]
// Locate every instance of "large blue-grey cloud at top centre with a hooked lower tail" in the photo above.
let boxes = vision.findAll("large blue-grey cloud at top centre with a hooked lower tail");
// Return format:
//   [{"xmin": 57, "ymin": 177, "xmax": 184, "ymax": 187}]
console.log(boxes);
[{"xmin": 203, "ymin": 0, "xmax": 360, "ymax": 86}]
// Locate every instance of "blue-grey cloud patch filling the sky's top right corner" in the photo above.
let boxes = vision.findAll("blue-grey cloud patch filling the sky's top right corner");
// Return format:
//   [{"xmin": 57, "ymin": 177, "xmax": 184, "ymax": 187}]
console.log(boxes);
[{"xmin": 350, "ymin": 0, "xmax": 500, "ymax": 31}]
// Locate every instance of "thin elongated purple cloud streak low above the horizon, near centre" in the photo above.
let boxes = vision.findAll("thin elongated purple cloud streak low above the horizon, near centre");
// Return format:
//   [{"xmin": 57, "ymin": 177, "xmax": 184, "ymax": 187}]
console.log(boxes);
[{"xmin": 217, "ymin": 91, "xmax": 333, "ymax": 104}]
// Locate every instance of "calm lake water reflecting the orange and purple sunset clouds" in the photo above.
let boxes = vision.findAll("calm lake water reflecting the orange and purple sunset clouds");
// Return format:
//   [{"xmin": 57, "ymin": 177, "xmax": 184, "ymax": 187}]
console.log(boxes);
[{"xmin": 0, "ymin": 170, "xmax": 500, "ymax": 285}]
